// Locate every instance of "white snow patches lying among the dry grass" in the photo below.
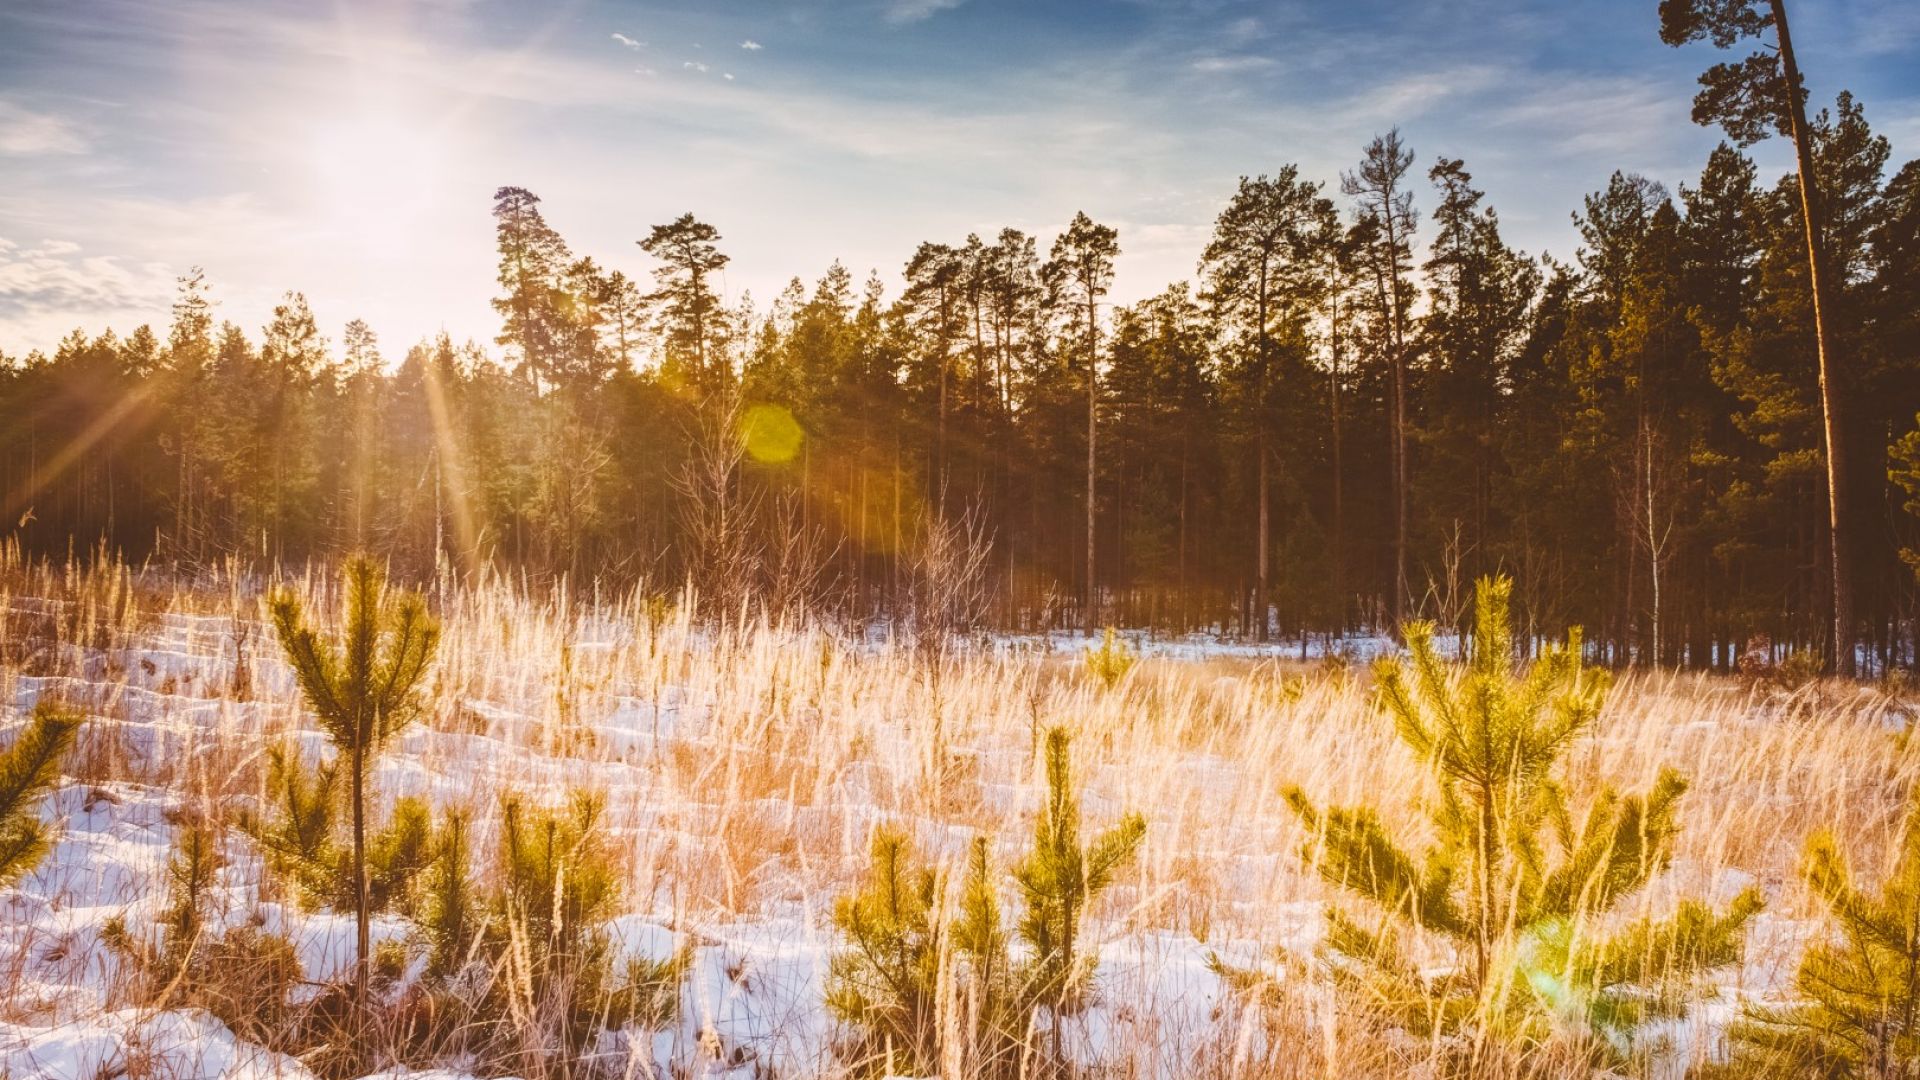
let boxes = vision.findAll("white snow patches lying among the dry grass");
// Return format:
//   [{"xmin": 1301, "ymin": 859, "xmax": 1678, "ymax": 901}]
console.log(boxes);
[{"xmin": 0, "ymin": 600, "xmax": 1843, "ymax": 1080}]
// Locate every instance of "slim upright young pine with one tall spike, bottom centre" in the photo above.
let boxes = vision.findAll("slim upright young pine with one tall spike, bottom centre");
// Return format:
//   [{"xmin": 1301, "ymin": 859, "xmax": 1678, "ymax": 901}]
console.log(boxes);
[{"xmin": 1014, "ymin": 726, "xmax": 1146, "ymax": 1059}]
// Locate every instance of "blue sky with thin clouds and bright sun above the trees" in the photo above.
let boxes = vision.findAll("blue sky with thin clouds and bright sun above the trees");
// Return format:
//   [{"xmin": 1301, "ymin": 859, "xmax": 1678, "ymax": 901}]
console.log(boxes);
[{"xmin": 0, "ymin": 0, "xmax": 1920, "ymax": 359}]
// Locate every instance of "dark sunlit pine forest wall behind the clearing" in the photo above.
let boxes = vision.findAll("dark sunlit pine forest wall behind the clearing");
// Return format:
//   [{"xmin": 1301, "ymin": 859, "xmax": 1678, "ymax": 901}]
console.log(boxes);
[{"xmin": 0, "ymin": 21, "xmax": 1920, "ymax": 665}]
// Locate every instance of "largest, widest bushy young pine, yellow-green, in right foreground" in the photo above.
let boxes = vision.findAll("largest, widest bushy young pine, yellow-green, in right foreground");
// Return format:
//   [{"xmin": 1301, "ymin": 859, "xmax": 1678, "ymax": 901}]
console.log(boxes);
[{"xmin": 1286, "ymin": 578, "xmax": 1761, "ymax": 1065}]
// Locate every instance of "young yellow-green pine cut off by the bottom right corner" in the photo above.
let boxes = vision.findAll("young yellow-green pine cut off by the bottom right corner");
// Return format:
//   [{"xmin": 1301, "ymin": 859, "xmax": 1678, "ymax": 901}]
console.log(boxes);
[{"xmin": 1713, "ymin": 798, "xmax": 1920, "ymax": 1080}]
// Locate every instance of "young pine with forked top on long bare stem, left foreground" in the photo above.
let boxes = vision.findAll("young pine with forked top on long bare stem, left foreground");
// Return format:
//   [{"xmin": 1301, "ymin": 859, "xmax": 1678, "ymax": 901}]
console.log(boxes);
[{"xmin": 271, "ymin": 555, "xmax": 440, "ymax": 1001}]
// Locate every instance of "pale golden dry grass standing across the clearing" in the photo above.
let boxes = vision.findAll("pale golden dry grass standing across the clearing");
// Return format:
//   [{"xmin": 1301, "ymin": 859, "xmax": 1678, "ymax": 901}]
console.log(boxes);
[{"xmin": 0, "ymin": 545, "xmax": 1920, "ymax": 1078}]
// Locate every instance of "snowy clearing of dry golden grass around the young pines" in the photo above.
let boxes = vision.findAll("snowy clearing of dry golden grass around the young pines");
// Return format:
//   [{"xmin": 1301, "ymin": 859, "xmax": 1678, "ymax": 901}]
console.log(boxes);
[{"xmin": 0, "ymin": 559, "xmax": 1920, "ymax": 1078}]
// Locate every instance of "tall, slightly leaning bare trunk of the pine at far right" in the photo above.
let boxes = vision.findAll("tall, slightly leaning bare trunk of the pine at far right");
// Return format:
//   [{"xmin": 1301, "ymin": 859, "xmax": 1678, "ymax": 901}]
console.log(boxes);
[{"xmin": 1772, "ymin": 0, "xmax": 1855, "ymax": 676}]
